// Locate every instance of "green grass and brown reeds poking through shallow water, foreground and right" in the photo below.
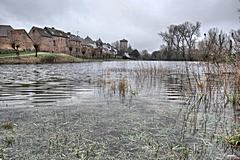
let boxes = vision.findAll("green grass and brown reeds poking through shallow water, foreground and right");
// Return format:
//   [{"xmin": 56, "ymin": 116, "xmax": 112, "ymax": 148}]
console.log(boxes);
[{"xmin": 0, "ymin": 60, "xmax": 240, "ymax": 160}]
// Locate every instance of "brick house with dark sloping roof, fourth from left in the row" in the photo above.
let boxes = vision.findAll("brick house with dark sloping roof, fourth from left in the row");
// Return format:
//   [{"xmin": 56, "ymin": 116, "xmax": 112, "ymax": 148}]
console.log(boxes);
[{"xmin": 44, "ymin": 27, "xmax": 69, "ymax": 53}]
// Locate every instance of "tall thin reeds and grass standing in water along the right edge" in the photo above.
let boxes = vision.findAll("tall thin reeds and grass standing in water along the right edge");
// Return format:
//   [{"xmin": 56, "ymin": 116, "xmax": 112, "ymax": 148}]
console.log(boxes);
[{"xmin": 177, "ymin": 63, "xmax": 240, "ymax": 159}]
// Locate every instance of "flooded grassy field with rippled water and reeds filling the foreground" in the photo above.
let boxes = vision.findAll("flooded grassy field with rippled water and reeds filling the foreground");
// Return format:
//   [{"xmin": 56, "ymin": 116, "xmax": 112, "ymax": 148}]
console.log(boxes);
[{"xmin": 0, "ymin": 61, "xmax": 240, "ymax": 160}]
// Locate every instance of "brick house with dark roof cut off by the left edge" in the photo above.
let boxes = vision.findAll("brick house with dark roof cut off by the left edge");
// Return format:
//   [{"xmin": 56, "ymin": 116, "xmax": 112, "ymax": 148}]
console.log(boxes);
[{"xmin": 0, "ymin": 25, "xmax": 13, "ymax": 50}]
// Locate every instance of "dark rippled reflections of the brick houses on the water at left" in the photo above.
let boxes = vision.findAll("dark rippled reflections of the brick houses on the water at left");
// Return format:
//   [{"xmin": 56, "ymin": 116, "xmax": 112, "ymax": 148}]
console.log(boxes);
[{"xmin": 0, "ymin": 65, "xmax": 93, "ymax": 107}]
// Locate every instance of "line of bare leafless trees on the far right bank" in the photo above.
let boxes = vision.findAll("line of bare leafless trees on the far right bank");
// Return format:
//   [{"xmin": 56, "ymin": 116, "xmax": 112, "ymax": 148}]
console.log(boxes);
[{"xmin": 155, "ymin": 22, "xmax": 240, "ymax": 61}]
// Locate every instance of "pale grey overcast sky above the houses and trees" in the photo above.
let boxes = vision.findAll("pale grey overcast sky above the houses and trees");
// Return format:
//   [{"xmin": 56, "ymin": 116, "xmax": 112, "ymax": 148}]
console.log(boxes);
[{"xmin": 0, "ymin": 0, "xmax": 240, "ymax": 51}]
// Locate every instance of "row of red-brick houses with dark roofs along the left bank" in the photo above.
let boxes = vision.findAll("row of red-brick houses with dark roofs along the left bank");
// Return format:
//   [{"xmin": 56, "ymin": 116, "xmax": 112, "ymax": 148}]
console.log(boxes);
[{"xmin": 0, "ymin": 25, "xmax": 122, "ymax": 57}]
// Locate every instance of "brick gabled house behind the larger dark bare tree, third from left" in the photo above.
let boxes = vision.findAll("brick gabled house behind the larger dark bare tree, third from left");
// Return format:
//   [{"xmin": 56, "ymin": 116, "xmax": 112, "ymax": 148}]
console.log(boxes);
[{"xmin": 29, "ymin": 26, "xmax": 54, "ymax": 52}]
